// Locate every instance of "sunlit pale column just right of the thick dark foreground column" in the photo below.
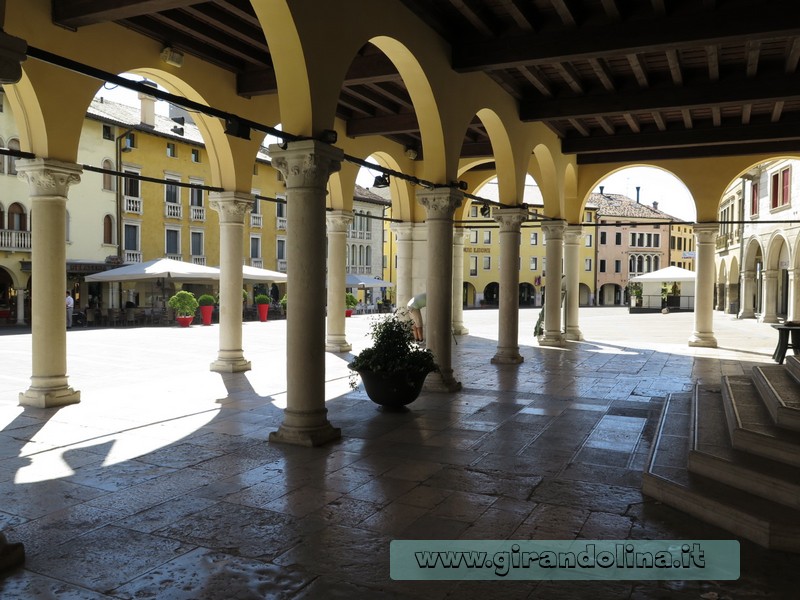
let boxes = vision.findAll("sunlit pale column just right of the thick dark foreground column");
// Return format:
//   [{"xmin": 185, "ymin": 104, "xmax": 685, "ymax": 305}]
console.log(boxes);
[{"xmin": 325, "ymin": 210, "xmax": 353, "ymax": 352}]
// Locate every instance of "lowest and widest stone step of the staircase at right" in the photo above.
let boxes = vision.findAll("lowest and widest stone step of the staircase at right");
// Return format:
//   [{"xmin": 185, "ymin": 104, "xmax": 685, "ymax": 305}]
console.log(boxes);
[{"xmin": 642, "ymin": 394, "xmax": 800, "ymax": 552}]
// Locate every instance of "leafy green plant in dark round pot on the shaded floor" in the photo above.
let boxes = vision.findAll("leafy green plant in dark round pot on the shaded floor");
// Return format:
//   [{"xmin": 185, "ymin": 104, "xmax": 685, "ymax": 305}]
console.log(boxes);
[{"xmin": 347, "ymin": 315, "xmax": 439, "ymax": 410}]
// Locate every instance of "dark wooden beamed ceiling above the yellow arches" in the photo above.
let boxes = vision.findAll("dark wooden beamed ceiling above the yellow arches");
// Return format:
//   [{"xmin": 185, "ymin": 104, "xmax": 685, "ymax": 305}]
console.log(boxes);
[{"xmin": 53, "ymin": 0, "xmax": 800, "ymax": 164}]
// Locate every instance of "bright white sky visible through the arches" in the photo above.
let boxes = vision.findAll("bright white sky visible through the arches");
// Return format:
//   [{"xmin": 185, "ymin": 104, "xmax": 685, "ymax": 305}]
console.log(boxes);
[{"xmin": 98, "ymin": 74, "xmax": 697, "ymax": 221}]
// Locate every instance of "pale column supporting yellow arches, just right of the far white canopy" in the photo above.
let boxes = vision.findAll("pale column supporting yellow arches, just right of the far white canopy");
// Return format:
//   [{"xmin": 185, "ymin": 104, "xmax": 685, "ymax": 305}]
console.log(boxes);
[{"xmin": 689, "ymin": 223, "xmax": 719, "ymax": 348}]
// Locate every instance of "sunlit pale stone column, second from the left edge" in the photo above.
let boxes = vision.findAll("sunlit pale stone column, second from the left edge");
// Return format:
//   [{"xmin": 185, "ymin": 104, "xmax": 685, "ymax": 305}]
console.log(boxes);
[{"xmin": 209, "ymin": 192, "xmax": 254, "ymax": 373}]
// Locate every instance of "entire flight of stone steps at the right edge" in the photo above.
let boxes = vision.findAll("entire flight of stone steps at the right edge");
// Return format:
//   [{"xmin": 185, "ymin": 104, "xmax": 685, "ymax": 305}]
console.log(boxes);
[{"xmin": 642, "ymin": 356, "xmax": 800, "ymax": 552}]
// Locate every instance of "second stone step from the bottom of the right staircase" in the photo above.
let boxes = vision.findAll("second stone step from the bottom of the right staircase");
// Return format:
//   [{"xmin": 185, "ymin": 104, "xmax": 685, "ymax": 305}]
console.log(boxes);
[{"xmin": 688, "ymin": 385, "xmax": 800, "ymax": 509}]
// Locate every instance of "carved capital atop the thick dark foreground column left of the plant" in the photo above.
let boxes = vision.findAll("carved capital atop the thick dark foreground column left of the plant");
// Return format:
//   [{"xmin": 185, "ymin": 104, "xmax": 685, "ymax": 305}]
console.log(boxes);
[{"xmin": 269, "ymin": 140, "xmax": 344, "ymax": 189}]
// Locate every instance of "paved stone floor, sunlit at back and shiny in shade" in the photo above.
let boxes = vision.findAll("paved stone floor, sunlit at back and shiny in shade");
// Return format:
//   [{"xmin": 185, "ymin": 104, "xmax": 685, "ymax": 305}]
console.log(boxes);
[{"xmin": 0, "ymin": 308, "xmax": 800, "ymax": 600}]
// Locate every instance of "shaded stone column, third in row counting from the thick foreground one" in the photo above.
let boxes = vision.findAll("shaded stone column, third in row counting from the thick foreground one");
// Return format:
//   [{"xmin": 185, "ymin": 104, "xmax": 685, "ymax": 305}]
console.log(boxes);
[{"xmin": 492, "ymin": 207, "xmax": 528, "ymax": 364}]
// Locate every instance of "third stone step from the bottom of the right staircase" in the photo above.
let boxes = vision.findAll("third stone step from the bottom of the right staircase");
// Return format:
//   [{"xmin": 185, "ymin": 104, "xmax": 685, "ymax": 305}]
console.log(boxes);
[{"xmin": 722, "ymin": 375, "xmax": 800, "ymax": 467}]
